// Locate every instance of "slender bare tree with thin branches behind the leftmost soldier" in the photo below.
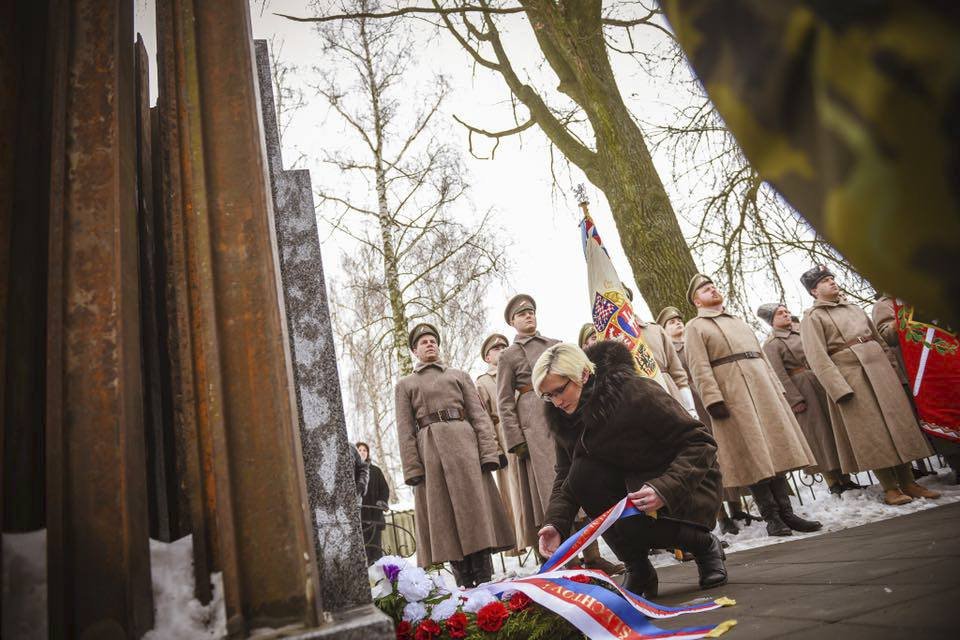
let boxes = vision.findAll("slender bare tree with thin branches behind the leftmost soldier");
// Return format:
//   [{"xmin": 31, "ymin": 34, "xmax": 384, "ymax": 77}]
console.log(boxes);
[{"xmin": 316, "ymin": 0, "xmax": 506, "ymax": 381}]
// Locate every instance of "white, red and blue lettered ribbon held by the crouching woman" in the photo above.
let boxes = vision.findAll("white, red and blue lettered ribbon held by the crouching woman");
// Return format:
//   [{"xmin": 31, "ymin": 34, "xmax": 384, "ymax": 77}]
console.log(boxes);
[{"xmin": 468, "ymin": 498, "xmax": 736, "ymax": 640}]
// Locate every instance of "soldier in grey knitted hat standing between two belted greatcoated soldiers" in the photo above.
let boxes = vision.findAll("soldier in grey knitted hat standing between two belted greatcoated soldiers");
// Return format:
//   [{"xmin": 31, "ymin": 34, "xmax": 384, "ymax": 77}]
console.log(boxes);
[{"xmin": 757, "ymin": 302, "xmax": 861, "ymax": 495}]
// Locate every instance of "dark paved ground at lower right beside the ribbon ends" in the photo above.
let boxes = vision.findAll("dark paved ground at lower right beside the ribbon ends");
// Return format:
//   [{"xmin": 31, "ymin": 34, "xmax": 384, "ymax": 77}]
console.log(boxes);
[{"xmin": 656, "ymin": 504, "xmax": 960, "ymax": 640}]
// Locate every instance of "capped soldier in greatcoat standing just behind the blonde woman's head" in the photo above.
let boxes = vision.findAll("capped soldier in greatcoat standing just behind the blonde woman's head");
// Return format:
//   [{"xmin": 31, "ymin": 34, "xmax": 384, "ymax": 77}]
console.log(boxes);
[{"xmin": 497, "ymin": 294, "xmax": 559, "ymax": 547}]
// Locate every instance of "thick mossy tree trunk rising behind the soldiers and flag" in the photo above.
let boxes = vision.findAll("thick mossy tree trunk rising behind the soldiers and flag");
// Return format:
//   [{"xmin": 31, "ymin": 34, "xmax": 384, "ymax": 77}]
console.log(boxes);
[{"xmin": 521, "ymin": 0, "xmax": 697, "ymax": 318}]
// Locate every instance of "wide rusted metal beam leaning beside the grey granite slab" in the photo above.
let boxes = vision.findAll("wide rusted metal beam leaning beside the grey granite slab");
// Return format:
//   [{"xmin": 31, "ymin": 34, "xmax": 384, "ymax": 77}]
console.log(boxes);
[{"xmin": 158, "ymin": 0, "xmax": 318, "ymax": 635}]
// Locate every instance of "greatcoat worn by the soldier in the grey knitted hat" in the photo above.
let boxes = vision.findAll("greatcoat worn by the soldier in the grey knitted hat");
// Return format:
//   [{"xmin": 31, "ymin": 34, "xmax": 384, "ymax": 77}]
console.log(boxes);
[{"xmin": 763, "ymin": 329, "xmax": 840, "ymax": 472}]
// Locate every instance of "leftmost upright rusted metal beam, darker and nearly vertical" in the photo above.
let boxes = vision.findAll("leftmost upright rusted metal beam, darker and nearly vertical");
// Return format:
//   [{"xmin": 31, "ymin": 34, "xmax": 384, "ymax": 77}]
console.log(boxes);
[{"xmin": 47, "ymin": 0, "xmax": 153, "ymax": 638}]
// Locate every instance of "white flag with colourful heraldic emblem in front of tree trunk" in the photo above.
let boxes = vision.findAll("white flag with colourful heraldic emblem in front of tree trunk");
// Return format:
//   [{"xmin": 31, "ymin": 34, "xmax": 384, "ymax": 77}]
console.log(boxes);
[{"xmin": 577, "ymin": 186, "xmax": 667, "ymax": 389}]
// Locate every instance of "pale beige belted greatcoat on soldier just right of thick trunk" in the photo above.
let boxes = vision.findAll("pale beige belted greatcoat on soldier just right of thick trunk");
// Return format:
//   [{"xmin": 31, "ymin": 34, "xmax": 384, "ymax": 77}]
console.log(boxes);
[{"xmin": 684, "ymin": 309, "xmax": 816, "ymax": 487}]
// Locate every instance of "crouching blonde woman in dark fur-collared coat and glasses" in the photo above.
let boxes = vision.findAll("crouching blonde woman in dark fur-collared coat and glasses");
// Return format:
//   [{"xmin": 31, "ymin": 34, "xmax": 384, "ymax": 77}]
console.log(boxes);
[{"xmin": 533, "ymin": 340, "xmax": 727, "ymax": 597}]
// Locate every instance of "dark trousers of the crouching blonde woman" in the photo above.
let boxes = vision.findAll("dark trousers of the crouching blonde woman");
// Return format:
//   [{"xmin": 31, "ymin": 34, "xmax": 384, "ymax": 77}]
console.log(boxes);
[{"xmin": 567, "ymin": 456, "xmax": 699, "ymax": 562}]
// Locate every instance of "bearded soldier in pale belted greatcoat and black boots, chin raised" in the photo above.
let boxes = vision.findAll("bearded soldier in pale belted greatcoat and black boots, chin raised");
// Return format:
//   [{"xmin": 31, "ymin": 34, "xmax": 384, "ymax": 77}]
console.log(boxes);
[{"xmin": 684, "ymin": 274, "xmax": 821, "ymax": 536}]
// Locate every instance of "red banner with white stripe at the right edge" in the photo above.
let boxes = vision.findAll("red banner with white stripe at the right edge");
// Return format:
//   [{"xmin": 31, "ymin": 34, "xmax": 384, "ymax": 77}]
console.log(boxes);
[{"xmin": 894, "ymin": 300, "xmax": 960, "ymax": 443}]
